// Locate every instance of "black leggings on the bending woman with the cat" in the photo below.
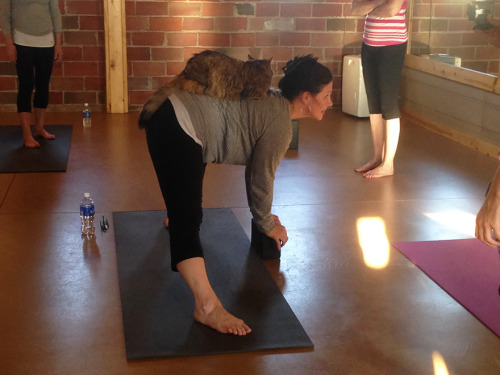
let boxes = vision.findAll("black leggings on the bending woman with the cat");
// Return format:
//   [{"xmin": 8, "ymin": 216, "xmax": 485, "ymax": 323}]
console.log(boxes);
[{"xmin": 146, "ymin": 100, "xmax": 206, "ymax": 271}]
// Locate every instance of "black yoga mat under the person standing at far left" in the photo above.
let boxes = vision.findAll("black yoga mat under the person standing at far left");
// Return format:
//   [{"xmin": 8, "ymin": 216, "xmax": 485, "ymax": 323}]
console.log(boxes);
[{"xmin": 0, "ymin": 125, "xmax": 73, "ymax": 173}]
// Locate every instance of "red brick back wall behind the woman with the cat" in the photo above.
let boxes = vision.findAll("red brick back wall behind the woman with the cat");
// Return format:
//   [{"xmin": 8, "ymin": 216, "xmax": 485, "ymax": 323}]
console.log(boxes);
[{"xmin": 0, "ymin": 0, "xmax": 364, "ymax": 110}]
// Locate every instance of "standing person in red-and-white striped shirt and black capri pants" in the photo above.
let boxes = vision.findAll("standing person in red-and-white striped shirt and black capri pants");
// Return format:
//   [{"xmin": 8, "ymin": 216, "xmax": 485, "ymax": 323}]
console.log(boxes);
[{"xmin": 351, "ymin": 0, "xmax": 408, "ymax": 178}]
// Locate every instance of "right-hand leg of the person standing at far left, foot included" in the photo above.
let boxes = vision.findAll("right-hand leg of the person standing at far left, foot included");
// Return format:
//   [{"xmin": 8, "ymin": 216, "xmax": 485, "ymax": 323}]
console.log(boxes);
[{"xmin": 33, "ymin": 47, "xmax": 55, "ymax": 139}]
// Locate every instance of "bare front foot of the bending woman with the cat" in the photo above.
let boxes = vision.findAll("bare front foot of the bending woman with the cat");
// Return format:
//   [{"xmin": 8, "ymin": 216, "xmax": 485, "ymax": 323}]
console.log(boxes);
[{"xmin": 194, "ymin": 302, "xmax": 252, "ymax": 336}]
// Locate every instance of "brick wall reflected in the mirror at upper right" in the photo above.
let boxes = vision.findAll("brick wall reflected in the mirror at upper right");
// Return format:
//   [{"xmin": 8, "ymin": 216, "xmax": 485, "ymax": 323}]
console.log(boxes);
[{"xmin": 412, "ymin": 0, "xmax": 500, "ymax": 75}]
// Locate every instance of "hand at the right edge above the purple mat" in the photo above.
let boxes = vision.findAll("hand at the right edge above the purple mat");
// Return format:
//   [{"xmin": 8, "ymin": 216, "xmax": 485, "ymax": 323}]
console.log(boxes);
[{"xmin": 476, "ymin": 192, "xmax": 500, "ymax": 247}]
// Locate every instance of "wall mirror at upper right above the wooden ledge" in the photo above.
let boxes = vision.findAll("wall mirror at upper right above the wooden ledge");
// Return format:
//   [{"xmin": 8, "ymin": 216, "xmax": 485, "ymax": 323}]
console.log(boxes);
[{"xmin": 410, "ymin": 0, "xmax": 500, "ymax": 76}]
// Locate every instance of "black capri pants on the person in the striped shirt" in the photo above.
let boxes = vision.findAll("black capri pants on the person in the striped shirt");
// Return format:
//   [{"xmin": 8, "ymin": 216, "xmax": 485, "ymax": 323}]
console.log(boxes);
[{"xmin": 361, "ymin": 42, "xmax": 407, "ymax": 120}]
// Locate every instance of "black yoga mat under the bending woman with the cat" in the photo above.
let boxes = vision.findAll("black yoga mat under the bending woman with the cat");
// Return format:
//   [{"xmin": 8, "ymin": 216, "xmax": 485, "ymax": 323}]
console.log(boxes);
[{"xmin": 113, "ymin": 209, "xmax": 313, "ymax": 359}]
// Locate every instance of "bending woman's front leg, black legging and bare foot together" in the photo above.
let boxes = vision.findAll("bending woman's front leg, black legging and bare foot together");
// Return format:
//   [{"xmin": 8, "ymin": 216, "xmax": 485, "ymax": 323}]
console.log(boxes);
[{"xmin": 146, "ymin": 101, "xmax": 251, "ymax": 335}]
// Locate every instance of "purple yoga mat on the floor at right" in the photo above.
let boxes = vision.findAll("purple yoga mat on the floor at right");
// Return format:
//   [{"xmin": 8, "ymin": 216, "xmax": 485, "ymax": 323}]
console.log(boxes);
[{"xmin": 394, "ymin": 238, "xmax": 500, "ymax": 337}]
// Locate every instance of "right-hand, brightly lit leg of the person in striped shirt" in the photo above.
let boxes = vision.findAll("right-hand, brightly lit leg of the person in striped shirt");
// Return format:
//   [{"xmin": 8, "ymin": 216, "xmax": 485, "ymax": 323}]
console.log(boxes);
[{"xmin": 363, "ymin": 43, "xmax": 406, "ymax": 178}]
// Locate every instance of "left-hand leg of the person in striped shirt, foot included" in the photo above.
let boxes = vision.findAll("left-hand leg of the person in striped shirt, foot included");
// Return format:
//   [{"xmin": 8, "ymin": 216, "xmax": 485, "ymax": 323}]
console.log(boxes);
[{"xmin": 354, "ymin": 44, "xmax": 385, "ymax": 173}]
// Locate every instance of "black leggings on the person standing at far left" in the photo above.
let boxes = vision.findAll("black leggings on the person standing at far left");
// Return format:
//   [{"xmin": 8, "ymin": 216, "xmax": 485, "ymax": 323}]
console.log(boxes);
[{"xmin": 15, "ymin": 44, "xmax": 54, "ymax": 112}]
